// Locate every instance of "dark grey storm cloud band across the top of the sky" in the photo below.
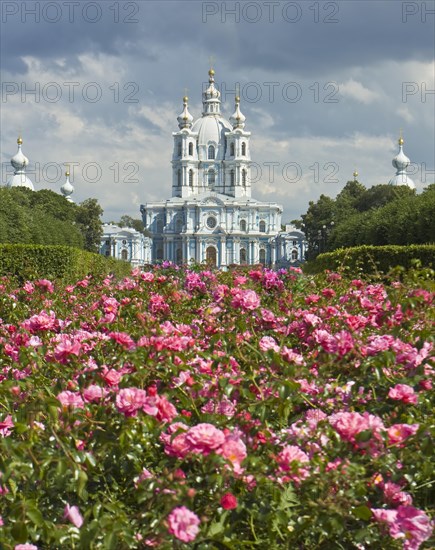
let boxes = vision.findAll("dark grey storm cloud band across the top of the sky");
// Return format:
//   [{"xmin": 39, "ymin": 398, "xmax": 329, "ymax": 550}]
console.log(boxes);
[{"xmin": 1, "ymin": 0, "xmax": 435, "ymax": 75}]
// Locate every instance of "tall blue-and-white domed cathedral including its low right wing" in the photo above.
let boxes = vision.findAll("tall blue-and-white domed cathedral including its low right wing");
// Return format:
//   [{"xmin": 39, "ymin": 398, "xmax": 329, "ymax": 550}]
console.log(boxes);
[{"xmin": 141, "ymin": 69, "xmax": 304, "ymax": 268}]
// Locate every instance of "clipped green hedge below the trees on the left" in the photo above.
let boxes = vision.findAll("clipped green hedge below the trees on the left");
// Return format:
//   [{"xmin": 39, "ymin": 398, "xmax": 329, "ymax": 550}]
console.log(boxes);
[{"xmin": 0, "ymin": 244, "xmax": 131, "ymax": 282}]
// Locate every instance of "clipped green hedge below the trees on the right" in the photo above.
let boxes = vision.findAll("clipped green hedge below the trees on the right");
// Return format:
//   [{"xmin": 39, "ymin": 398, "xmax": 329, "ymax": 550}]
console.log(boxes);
[{"xmin": 304, "ymin": 244, "xmax": 435, "ymax": 275}]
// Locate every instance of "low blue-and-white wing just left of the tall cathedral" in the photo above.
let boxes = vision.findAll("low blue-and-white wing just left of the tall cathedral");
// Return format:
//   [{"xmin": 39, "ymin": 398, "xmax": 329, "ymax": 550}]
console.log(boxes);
[{"xmin": 99, "ymin": 223, "xmax": 152, "ymax": 267}]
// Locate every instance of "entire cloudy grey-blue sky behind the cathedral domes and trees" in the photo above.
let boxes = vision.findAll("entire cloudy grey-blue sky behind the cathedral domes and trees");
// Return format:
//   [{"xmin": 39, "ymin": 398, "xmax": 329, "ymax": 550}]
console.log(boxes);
[{"xmin": 0, "ymin": 0, "xmax": 435, "ymax": 221}]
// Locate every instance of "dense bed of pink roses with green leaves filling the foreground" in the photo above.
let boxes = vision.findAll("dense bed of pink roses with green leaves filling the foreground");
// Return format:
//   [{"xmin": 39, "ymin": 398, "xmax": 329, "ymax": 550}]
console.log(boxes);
[{"xmin": 0, "ymin": 265, "xmax": 435, "ymax": 550}]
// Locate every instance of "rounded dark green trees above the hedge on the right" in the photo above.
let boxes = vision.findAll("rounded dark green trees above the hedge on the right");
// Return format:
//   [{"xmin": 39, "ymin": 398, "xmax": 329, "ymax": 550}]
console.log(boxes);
[{"xmin": 302, "ymin": 181, "xmax": 435, "ymax": 260}]
